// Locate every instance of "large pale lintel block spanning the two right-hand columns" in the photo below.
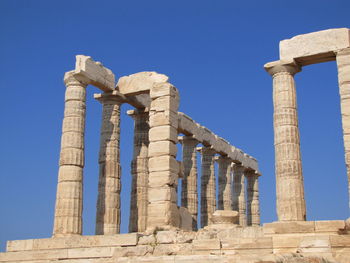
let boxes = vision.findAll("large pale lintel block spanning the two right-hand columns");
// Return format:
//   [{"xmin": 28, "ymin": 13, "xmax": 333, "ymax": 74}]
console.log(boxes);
[{"xmin": 280, "ymin": 28, "xmax": 350, "ymax": 65}]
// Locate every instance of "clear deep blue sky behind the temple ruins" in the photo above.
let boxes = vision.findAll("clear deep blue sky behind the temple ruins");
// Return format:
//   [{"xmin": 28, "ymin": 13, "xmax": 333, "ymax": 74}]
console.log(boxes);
[{"xmin": 0, "ymin": 0, "xmax": 350, "ymax": 253}]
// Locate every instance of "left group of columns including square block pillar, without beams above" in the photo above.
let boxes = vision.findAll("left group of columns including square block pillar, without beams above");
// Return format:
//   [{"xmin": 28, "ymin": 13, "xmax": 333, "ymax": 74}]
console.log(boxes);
[{"xmin": 53, "ymin": 75, "xmax": 260, "ymax": 237}]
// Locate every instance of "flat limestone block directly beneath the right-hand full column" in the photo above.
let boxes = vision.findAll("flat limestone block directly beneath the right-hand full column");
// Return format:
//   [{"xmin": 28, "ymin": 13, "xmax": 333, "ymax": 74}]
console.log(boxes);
[{"xmin": 263, "ymin": 221, "xmax": 315, "ymax": 234}]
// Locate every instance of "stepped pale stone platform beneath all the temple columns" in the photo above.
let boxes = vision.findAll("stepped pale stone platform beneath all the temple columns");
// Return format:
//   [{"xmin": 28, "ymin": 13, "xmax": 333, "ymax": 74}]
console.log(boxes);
[{"xmin": 0, "ymin": 220, "xmax": 350, "ymax": 263}]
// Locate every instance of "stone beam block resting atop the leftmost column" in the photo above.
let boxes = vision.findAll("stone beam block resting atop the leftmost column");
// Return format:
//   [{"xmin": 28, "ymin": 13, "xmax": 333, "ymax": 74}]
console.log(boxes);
[{"xmin": 74, "ymin": 55, "xmax": 115, "ymax": 91}]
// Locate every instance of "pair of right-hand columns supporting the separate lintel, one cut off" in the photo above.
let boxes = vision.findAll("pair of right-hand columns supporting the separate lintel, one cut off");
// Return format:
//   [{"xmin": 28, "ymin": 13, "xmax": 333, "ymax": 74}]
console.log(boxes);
[{"xmin": 265, "ymin": 48, "xmax": 350, "ymax": 221}]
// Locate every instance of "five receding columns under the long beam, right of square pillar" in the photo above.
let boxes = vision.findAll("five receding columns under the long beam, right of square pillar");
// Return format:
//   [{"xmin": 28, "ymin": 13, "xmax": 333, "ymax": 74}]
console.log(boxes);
[{"xmin": 181, "ymin": 136, "xmax": 260, "ymax": 230}]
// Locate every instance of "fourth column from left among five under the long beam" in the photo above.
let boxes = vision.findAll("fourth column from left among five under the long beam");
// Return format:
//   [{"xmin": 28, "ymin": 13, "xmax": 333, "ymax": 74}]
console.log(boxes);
[{"xmin": 232, "ymin": 164, "xmax": 247, "ymax": 226}]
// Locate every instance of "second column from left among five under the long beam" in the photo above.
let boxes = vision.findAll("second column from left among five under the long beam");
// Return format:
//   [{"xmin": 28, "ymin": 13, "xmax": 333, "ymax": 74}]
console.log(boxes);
[{"xmin": 201, "ymin": 147, "xmax": 216, "ymax": 227}]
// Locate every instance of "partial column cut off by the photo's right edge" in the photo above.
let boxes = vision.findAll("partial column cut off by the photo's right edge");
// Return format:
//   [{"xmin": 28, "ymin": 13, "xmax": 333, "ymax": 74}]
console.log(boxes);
[{"xmin": 337, "ymin": 48, "xmax": 350, "ymax": 208}]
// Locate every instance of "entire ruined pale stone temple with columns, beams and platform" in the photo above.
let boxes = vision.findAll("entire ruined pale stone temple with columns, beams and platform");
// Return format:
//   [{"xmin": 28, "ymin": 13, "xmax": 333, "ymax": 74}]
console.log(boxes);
[{"xmin": 0, "ymin": 28, "xmax": 350, "ymax": 263}]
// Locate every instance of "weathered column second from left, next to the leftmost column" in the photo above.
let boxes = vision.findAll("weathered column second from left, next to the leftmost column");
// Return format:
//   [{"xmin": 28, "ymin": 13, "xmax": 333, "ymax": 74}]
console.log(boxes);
[{"xmin": 95, "ymin": 93, "xmax": 122, "ymax": 235}]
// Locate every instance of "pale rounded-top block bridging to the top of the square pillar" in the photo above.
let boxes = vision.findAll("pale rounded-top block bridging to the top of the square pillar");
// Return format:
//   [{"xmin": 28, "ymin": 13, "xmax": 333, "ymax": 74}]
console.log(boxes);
[{"xmin": 117, "ymin": 72, "xmax": 169, "ymax": 96}]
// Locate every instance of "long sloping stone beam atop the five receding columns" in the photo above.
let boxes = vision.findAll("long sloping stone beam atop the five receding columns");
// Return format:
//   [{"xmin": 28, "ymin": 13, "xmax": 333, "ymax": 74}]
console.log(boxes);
[{"xmin": 178, "ymin": 112, "xmax": 258, "ymax": 171}]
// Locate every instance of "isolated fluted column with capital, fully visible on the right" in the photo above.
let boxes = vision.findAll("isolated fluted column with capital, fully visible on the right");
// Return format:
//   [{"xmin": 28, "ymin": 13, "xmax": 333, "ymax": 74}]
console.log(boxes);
[{"xmin": 265, "ymin": 61, "xmax": 306, "ymax": 221}]
